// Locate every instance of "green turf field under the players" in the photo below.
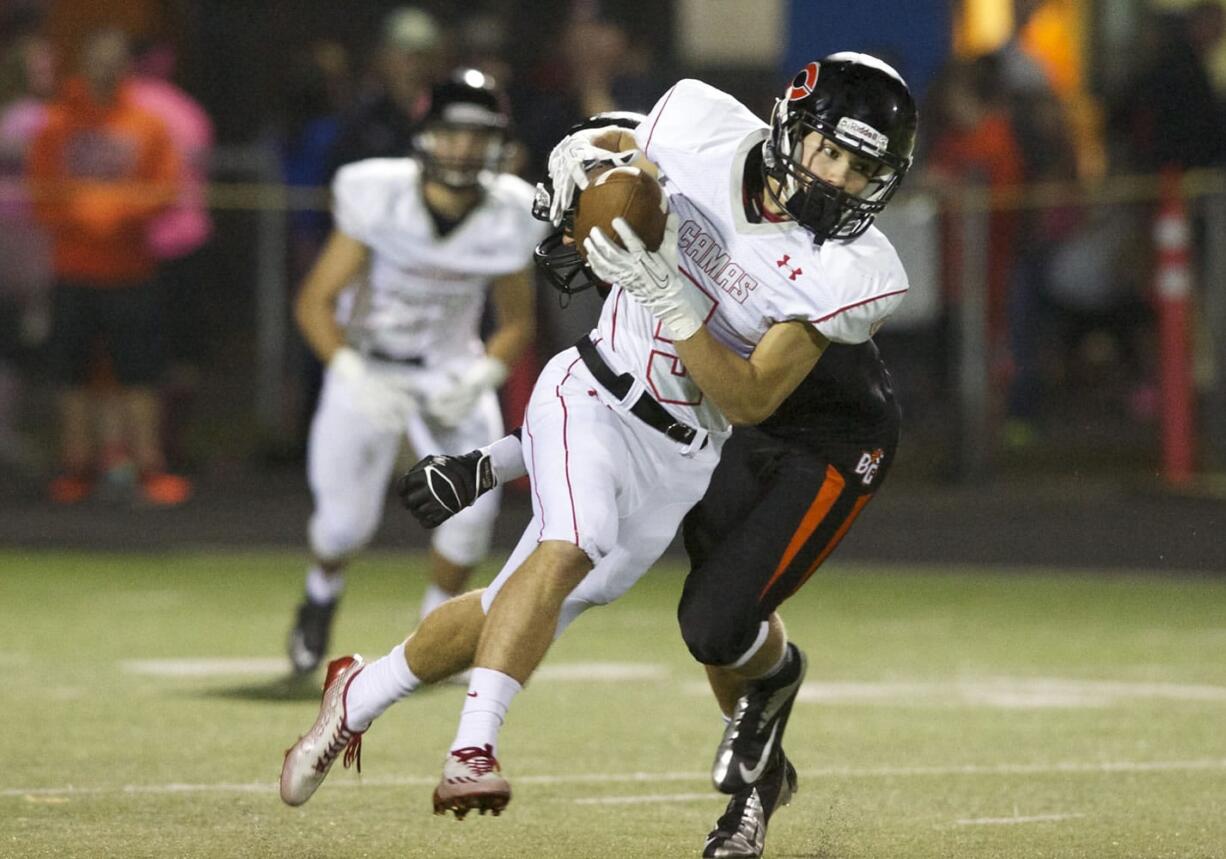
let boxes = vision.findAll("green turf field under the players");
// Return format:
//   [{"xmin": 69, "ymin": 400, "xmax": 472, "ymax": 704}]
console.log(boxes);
[{"xmin": 0, "ymin": 551, "xmax": 1226, "ymax": 859}]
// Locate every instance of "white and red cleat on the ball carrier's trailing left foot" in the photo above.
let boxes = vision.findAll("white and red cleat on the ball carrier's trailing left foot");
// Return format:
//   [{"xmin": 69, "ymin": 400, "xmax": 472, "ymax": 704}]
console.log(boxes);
[{"xmin": 281, "ymin": 654, "xmax": 365, "ymax": 805}]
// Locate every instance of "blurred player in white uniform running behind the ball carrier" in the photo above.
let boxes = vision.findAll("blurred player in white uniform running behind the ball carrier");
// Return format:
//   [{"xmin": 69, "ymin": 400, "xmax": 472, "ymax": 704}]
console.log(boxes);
[{"xmin": 289, "ymin": 70, "xmax": 543, "ymax": 672}]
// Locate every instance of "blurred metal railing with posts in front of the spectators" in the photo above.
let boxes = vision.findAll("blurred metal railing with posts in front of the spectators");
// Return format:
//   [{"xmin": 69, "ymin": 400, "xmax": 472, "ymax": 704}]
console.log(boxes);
[{"xmin": 0, "ymin": 150, "xmax": 1226, "ymax": 478}]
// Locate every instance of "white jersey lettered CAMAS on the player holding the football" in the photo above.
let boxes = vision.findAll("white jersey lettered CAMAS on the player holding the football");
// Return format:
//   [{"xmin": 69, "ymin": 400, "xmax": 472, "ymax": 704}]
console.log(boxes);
[{"xmin": 593, "ymin": 80, "xmax": 907, "ymax": 431}]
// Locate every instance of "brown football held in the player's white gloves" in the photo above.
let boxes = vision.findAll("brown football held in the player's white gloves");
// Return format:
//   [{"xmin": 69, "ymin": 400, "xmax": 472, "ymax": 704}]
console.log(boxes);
[{"xmin": 575, "ymin": 167, "xmax": 668, "ymax": 260}]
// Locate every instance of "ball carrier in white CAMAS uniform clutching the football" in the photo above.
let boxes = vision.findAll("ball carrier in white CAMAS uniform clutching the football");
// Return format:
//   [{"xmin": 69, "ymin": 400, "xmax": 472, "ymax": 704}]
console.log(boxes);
[{"xmin": 281, "ymin": 58, "xmax": 913, "ymax": 833}]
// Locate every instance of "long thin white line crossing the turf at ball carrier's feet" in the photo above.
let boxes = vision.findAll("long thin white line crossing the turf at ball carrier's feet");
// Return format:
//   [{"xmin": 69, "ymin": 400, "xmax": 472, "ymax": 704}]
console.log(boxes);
[{"xmin": 9, "ymin": 759, "xmax": 1226, "ymax": 801}]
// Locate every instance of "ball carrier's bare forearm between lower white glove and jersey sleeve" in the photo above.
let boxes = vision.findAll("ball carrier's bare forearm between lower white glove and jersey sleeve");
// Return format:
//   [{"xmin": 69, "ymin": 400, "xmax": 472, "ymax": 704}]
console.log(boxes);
[{"xmin": 673, "ymin": 327, "xmax": 787, "ymax": 424}]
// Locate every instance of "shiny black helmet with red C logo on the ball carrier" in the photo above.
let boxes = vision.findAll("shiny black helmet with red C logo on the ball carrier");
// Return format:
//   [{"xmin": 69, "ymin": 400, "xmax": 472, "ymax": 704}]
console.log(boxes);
[{"xmin": 763, "ymin": 51, "xmax": 918, "ymax": 243}]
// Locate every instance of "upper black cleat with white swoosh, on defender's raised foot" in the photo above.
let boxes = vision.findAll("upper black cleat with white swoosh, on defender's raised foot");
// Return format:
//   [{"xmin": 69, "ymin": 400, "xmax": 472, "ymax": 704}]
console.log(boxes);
[{"xmin": 711, "ymin": 642, "xmax": 808, "ymax": 794}]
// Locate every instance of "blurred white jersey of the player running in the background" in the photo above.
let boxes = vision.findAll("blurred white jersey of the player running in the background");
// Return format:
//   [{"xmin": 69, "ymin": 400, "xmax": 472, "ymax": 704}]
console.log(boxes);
[{"xmin": 332, "ymin": 158, "xmax": 547, "ymax": 363}]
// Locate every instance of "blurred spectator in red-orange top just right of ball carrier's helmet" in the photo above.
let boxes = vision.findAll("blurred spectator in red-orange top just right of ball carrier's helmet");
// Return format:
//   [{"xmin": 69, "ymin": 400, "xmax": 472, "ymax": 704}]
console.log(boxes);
[{"xmin": 923, "ymin": 59, "xmax": 1024, "ymax": 399}]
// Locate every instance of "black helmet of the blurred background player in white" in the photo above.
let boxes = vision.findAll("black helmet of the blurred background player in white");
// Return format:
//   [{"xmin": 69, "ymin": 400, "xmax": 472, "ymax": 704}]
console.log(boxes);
[{"xmin": 413, "ymin": 69, "xmax": 510, "ymax": 189}]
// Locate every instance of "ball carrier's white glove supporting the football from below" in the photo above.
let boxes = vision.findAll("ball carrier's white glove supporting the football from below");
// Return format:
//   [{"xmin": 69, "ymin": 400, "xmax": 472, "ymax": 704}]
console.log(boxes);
[{"xmin": 584, "ymin": 214, "xmax": 709, "ymax": 341}]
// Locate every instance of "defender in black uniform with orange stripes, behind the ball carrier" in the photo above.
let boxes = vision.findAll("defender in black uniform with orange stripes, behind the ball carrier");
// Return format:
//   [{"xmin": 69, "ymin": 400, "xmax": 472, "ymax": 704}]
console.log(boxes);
[{"xmin": 397, "ymin": 60, "xmax": 917, "ymax": 857}]
